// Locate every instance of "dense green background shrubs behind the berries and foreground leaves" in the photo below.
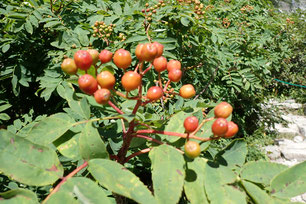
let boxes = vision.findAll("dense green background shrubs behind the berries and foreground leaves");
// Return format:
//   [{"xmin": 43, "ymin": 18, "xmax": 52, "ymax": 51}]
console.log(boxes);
[{"xmin": 0, "ymin": 0, "xmax": 306, "ymax": 202}]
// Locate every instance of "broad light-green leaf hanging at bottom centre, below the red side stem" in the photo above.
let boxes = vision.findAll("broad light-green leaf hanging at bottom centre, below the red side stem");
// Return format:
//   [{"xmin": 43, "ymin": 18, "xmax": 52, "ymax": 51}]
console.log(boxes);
[{"xmin": 149, "ymin": 145, "xmax": 185, "ymax": 204}]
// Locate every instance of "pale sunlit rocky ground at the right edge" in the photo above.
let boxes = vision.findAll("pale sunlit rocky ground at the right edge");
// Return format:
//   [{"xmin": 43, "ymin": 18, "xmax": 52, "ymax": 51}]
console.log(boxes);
[{"xmin": 265, "ymin": 100, "xmax": 306, "ymax": 203}]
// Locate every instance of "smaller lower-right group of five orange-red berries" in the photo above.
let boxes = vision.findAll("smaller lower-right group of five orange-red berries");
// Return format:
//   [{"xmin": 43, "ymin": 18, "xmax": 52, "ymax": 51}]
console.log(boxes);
[{"xmin": 184, "ymin": 102, "xmax": 238, "ymax": 158}]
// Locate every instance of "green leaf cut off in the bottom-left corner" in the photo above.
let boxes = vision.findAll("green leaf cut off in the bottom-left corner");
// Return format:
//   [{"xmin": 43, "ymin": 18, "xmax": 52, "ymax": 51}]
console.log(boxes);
[{"xmin": 0, "ymin": 188, "xmax": 39, "ymax": 204}]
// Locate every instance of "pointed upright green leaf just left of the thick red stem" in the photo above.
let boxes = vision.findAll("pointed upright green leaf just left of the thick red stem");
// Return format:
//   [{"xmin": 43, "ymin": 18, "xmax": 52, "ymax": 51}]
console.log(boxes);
[{"xmin": 79, "ymin": 122, "xmax": 108, "ymax": 160}]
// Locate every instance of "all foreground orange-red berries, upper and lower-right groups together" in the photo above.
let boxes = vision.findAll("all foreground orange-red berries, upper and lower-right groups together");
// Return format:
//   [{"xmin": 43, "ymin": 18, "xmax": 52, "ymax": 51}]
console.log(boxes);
[{"xmin": 61, "ymin": 42, "xmax": 238, "ymax": 162}]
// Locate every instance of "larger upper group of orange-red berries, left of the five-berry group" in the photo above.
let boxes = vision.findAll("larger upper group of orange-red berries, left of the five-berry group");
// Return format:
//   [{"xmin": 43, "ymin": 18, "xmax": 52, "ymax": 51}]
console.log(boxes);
[{"xmin": 61, "ymin": 42, "xmax": 196, "ymax": 107}]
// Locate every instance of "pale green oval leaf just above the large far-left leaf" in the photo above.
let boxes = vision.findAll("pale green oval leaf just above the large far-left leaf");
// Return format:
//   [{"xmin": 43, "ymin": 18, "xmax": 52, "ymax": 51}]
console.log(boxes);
[{"xmin": 27, "ymin": 113, "xmax": 75, "ymax": 145}]
